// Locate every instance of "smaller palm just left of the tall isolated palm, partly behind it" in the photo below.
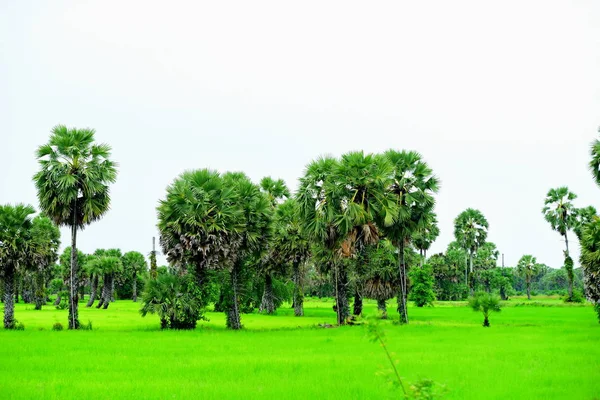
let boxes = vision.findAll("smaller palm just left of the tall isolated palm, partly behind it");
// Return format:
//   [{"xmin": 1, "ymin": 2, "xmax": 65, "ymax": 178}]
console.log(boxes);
[{"xmin": 30, "ymin": 216, "xmax": 60, "ymax": 310}]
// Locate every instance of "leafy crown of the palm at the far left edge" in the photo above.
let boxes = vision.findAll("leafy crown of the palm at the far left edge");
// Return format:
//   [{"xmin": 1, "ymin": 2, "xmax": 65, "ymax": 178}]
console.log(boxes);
[{"xmin": 0, "ymin": 204, "xmax": 35, "ymax": 274}]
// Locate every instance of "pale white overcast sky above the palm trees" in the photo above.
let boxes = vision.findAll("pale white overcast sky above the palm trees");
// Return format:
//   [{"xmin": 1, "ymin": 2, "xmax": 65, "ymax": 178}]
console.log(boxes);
[{"xmin": 0, "ymin": 0, "xmax": 600, "ymax": 267}]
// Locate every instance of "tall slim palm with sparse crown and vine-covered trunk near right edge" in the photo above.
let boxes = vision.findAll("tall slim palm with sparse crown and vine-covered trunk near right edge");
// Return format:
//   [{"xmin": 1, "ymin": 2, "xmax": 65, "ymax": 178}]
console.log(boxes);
[{"xmin": 542, "ymin": 186, "xmax": 578, "ymax": 299}]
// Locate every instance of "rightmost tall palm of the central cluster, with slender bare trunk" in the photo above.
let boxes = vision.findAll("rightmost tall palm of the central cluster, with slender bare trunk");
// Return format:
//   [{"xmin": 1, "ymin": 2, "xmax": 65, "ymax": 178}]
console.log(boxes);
[{"xmin": 385, "ymin": 150, "xmax": 440, "ymax": 323}]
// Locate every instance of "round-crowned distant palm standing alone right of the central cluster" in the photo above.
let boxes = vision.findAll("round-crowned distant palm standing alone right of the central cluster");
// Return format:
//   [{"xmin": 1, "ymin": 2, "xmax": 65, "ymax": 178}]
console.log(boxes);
[{"xmin": 454, "ymin": 208, "xmax": 489, "ymax": 294}]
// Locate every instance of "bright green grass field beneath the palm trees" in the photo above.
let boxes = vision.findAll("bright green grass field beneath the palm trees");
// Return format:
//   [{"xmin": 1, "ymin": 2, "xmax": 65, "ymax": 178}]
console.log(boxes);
[{"xmin": 0, "ymin": 297, "xmax": 600, "ymax": 399}]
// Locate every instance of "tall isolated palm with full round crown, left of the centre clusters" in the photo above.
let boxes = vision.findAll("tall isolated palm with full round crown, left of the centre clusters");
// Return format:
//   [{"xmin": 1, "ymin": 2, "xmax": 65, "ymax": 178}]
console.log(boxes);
[{"xmin": 33, "ymin": 125, "xmax": 117, "ymax": 329}]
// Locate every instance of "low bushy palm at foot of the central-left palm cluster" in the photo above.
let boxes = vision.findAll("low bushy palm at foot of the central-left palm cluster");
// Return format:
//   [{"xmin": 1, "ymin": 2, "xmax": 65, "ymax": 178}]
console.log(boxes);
[{"xmin": 140, "ymin": 273, "xmax": 206, "ymax": 329}]
